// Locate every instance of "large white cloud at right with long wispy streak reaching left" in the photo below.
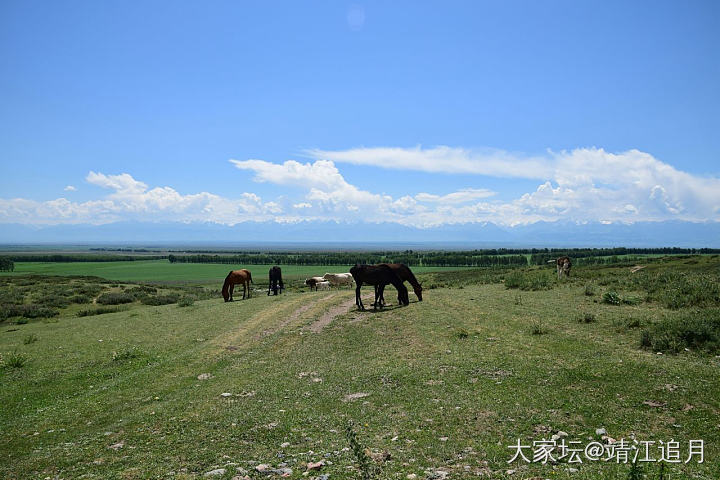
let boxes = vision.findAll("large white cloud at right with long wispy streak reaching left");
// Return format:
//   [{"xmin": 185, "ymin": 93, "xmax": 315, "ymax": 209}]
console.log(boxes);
[{"xmin": 306, "ymin": 146, "xmax": 720, "ymax": 225}]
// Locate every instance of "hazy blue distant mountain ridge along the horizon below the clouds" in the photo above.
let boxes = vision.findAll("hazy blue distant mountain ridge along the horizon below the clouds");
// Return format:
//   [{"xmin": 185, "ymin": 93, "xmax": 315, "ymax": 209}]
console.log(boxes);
[{"xmin": 0, "ymin": 221, "xmax": 720, "ymax": 248}]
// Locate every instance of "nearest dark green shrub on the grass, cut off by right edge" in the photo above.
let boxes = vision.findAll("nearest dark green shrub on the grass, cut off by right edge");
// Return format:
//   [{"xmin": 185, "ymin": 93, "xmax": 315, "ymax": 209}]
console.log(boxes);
[{"xmin": 640, "ymin": 310, "xmax": 720, "ymax": 354}]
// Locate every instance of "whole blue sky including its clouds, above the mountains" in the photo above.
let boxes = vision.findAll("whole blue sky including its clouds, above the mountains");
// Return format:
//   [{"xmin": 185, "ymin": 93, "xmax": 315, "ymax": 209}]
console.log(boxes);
[{"xmin": 0, "ymin": 0, "xmax": 720, "ymax": 228}]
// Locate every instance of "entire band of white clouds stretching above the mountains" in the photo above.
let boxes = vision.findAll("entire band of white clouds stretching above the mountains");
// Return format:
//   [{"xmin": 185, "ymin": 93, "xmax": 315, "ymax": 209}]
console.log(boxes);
[{"xmin": 0, "ymin": 147, "xmax": 720, "ymax": 227}]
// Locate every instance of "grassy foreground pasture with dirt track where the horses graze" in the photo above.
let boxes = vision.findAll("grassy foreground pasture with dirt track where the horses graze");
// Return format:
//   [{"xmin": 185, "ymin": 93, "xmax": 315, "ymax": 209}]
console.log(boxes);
[{"xmin": 0, "ymin": 257, "xmax": 720, "ymax": 480}]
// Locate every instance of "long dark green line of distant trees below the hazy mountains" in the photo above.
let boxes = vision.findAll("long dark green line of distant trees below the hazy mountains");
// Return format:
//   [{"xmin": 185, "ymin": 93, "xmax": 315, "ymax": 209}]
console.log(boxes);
[{"xmin": 0, "ymin": 247, "xmax": 720, "ymax": 269}]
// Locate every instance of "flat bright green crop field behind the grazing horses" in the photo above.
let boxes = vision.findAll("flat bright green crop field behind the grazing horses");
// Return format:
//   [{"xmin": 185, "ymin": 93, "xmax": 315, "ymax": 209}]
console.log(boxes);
[{"xmin": 0, "ymin": 260, "xmax": 472, "ymax": 285}]
